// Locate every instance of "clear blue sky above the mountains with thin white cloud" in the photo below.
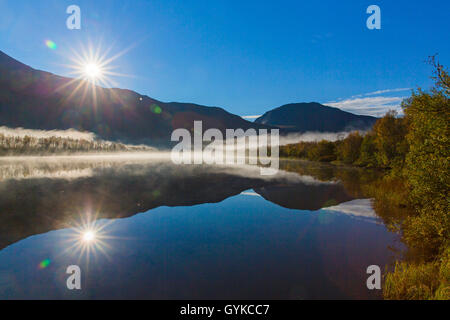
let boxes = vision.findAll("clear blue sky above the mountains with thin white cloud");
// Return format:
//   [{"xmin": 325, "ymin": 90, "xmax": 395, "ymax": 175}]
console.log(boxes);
[{"xmin": 0, "ymin": 0, "xmax": 450, "ymax": 115}]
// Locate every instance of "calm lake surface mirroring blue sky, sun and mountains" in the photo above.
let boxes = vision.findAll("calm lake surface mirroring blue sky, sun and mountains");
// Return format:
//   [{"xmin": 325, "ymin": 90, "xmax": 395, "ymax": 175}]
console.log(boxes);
[{"xmin": 0, "ymin": 157, "xmax": 401, "ymax": 299}]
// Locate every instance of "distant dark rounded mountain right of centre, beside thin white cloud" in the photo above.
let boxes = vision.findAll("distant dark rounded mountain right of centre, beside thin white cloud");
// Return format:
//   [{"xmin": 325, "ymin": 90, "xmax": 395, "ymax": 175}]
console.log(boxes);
[{"xmin": 255, "ymin": 102, "xmax": 377, "ymax": 132}]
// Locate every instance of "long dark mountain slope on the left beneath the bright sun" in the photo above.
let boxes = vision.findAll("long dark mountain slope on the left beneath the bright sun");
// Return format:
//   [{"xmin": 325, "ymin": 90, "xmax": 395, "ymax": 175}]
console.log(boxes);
[{"xmin": 0, "ymin": 51, "xmax": 268, "ymax": 145}]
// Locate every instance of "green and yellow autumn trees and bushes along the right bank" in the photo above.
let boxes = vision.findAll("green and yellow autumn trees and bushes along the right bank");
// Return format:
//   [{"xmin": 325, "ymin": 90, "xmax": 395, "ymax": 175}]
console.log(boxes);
[{"xmin": 280, "ymin": 57, "xmax": 450, "ymax": 300}]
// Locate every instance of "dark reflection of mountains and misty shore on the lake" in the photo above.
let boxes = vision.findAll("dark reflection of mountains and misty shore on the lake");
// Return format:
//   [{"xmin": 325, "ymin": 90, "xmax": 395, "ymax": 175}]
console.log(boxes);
[{"xmin": 0, "ymin": 158, "xmax": 390, "ymax": 248}]
